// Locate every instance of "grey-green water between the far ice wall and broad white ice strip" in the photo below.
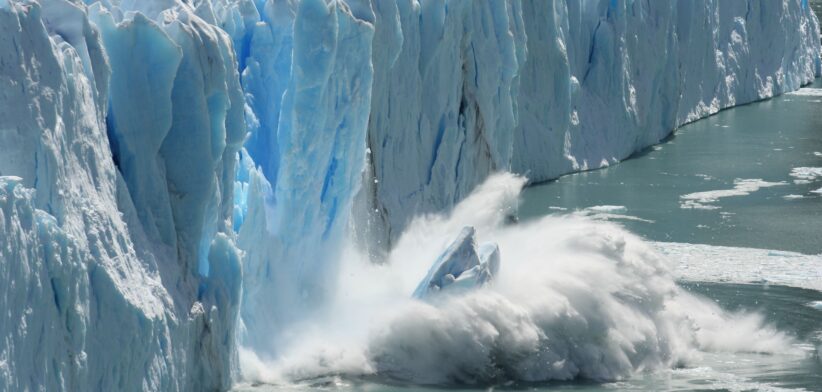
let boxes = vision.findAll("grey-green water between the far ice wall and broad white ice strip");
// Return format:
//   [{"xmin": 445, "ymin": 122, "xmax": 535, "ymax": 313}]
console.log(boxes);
[{"xmin": 519, "ymin": 82, "xmax": 822, "ymax": 254}]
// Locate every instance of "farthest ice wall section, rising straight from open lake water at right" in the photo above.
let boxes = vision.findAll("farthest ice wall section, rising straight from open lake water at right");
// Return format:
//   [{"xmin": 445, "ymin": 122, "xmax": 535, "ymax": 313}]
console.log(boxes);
[{"xmin": 512, "ymin": 0, "xmax": 819, "ymax": 181}]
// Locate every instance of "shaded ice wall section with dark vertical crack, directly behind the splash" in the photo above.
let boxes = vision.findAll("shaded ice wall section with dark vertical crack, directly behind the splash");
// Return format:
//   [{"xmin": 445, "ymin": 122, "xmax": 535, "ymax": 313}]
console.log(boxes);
[{"xmin": 358, "ymin": 0, "xmax": 526, "ymax": 249}]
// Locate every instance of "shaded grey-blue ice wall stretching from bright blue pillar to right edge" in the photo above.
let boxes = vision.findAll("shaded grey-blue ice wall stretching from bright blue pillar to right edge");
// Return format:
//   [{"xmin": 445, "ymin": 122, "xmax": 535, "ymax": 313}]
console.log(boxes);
[{"xmin": 363, "ymin": 0, "xmax": 820, "ymax": 248}]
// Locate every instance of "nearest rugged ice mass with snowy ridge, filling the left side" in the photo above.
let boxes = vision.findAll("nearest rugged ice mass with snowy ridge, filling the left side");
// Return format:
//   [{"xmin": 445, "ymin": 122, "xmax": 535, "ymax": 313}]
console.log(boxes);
[{"xmin": 0, "ymin": 0, "xmax": 245, "ymax": 391}]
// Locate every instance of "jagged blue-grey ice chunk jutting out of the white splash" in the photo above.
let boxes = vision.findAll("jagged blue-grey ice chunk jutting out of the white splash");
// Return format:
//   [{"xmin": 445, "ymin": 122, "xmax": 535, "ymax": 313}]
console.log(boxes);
[{"xmin": 414, "ymin": 226, "xmax": 500, "ymax": 299}]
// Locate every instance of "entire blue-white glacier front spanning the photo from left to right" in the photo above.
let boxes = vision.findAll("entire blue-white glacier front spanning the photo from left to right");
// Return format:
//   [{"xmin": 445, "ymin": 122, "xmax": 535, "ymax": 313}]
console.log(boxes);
[{"xmin": 0, "ymin": 0, "xmax": 822, "ymax": 391}]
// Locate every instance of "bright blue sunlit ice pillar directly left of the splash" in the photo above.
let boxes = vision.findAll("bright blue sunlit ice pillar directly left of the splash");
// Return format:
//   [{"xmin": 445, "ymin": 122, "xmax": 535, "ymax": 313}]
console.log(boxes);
[{"xmin": 235, "ymin": 0, "xmax": 374, "ymax": 350}]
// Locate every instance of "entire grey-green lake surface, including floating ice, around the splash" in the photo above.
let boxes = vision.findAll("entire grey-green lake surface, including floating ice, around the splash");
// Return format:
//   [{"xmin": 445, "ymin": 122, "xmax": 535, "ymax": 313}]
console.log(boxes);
[{"xmin": 237, "ymin": 81, "xmax": 822, "ymax": 392}]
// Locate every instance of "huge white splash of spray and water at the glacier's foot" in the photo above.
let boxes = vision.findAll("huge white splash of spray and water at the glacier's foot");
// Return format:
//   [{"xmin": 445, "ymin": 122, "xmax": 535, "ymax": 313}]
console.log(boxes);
[{"xmin": 235, "ymin": 174, "xmax": 807, "ymax": 385}]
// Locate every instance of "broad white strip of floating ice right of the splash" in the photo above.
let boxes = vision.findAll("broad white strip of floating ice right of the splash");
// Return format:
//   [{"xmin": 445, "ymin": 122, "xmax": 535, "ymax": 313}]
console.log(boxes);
[{"xmin": 653, "ymin": 242, "xmax": 822, "ymax": 290}]
